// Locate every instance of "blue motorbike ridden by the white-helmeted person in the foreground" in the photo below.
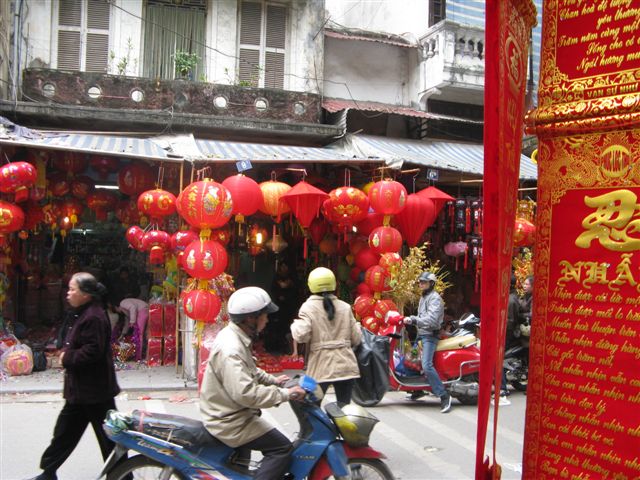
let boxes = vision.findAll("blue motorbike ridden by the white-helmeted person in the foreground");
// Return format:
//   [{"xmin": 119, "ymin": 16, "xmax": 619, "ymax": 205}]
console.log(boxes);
[{"xmin": 98, "ymin": 375, "xmax": 394, "ymax": 480}]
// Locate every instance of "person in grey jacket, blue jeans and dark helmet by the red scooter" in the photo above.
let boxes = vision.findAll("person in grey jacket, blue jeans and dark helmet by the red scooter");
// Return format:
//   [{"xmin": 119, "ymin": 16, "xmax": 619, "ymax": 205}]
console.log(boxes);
[{"xmin": 404, "ymin": 272, "xmax": 451, "ymax": 413}]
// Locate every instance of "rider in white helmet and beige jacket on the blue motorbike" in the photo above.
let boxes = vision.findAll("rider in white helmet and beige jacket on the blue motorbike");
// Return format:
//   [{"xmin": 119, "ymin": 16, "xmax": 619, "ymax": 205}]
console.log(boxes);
[{"xmin": 200, "ymin": 287, "xmax": 305, "ymax": 480}]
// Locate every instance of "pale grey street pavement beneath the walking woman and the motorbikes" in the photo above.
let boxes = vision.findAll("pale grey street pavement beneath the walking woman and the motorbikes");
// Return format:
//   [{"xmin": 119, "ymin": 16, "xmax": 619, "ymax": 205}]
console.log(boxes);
[{"xmin": 0, "ymin": 367, "xmax": 526, "ymax": 480}]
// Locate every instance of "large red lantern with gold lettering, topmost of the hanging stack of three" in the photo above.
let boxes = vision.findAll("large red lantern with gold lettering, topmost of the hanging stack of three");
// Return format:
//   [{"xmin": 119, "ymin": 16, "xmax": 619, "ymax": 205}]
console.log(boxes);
[{"xmin": 176, "ymin": 179, "xmax": 233, "ymax": 232}]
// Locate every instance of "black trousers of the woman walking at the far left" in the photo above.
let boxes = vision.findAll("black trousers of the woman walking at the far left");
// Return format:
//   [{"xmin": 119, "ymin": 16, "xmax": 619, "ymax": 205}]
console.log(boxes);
[{"xmin": 40, "ymin": 399, "xmax": 116, "ymax": 476}]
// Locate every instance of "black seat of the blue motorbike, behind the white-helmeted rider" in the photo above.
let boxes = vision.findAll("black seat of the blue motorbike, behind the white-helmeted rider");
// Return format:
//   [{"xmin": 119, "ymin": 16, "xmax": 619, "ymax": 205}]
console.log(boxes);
[{"xmin": 131, "ymin": 410, "xmax": 224, "ymax": 450}]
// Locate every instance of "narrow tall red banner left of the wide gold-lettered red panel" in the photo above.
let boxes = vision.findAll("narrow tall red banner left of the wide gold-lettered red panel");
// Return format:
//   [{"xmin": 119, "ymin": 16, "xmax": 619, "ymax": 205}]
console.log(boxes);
[{"xmin": 476, "ymin": 0, "xmax": 536, "ymax": 478}]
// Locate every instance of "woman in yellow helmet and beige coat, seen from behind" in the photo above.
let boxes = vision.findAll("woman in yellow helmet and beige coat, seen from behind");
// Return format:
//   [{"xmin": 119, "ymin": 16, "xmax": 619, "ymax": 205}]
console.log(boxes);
[{"xmin": 291, "ymin": 267, "xmax": 362, "ymax": 404}]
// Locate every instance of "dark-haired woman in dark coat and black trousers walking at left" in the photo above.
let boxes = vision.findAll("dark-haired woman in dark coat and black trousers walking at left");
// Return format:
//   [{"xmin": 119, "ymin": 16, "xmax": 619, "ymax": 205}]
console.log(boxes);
[{"xmin": 29, "ymin": 272, "xmax": 120, "ymax": 480}]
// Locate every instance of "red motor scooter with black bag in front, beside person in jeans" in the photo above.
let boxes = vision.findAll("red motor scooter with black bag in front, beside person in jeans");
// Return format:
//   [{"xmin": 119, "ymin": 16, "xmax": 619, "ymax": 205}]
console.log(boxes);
[{"xmin": 352, "ymin": 312, "xmax": 480, "ymax": 407}]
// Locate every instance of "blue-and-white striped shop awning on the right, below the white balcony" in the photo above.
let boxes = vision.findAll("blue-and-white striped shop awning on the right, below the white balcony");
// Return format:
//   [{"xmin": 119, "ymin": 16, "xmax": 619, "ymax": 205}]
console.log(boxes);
[{"xmin": 329, "ymin": 134, "xmax": 538, "ymax": 180}]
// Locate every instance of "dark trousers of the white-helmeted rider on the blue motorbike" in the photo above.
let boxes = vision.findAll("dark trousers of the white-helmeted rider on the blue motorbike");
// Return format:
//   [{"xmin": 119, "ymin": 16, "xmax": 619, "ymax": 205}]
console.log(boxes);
[{"xmin": 240, "ymin": 428, "xmax": 293, "ymax": 480}]
